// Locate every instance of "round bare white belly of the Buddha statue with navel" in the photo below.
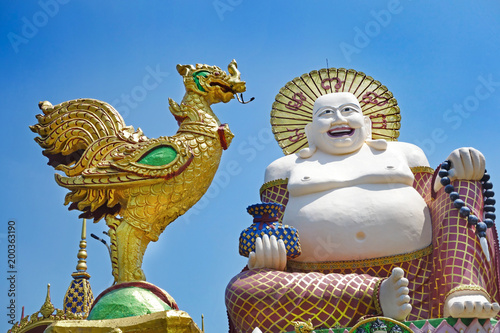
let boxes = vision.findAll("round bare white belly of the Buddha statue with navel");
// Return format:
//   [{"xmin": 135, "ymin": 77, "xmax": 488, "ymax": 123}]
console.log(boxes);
[{"xmin": 283, "ymin": 184, "xmax": 432, "ymax": 262}]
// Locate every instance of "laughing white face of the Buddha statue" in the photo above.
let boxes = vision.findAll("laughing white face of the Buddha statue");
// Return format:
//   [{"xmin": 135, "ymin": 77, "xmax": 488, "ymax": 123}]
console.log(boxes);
[{"xmin": 307, "ymin": 92, "xmax": 371, "ymax": 155}]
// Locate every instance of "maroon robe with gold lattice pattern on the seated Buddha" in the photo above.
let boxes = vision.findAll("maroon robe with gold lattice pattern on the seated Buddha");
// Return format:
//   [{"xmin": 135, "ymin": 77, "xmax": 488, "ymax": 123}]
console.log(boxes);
[{"xmin": 225, "ymin": 167, "xmax": 500, "ymax": 333}]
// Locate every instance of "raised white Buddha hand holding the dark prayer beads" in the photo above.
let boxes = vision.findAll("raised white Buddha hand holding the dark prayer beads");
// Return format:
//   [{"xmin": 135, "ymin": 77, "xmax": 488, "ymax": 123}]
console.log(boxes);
[{"xmin": 434, "ymin": 147, "xmax": 485, "ymax": 191}]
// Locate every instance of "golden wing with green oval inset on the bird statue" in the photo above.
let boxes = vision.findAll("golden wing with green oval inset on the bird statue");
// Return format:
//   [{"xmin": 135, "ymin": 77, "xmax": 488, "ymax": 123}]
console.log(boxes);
[{"xmin": 56, "ymin": 137, "xmax": 194, "ymax": 222}]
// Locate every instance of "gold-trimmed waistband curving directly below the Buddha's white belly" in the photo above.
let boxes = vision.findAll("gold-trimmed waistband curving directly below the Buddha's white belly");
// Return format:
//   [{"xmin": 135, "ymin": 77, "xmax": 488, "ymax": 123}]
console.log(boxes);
[{"xmin": 287, "ymin": 244, "xmax": 432, "ymax": 271}]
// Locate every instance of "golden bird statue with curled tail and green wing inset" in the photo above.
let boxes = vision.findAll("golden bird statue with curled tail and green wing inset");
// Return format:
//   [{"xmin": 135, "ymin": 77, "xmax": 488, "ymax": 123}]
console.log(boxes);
[{"xmin": 30, "ymin": 60, "xmax": 246, "ymax": 283}]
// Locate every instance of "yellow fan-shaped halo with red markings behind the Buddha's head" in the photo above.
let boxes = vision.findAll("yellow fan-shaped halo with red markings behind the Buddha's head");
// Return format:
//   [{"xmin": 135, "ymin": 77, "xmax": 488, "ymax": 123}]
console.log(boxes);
[{"xmin": 271, "ymin": 68, "xmax": 401, "ymax": 155}]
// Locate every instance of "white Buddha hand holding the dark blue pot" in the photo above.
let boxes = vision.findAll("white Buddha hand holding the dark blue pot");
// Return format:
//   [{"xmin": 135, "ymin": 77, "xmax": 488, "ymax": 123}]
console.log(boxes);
[{"xmin": 248, "ymin": 235, "xmax": 286, "ymax": 271}]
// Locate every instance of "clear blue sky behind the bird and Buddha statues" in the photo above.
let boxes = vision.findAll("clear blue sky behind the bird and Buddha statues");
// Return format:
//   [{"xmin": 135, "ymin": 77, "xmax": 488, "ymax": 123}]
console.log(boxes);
[{"xmin": 0, "ymin": 0, "xmax": 500, "ymax": 332}]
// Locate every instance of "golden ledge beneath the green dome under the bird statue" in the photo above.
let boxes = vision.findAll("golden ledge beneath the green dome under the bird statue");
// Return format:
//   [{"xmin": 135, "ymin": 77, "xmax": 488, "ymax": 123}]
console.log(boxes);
[{"xmin": 45, "ymin": 310, "xmax": 202, "ymax": 333}]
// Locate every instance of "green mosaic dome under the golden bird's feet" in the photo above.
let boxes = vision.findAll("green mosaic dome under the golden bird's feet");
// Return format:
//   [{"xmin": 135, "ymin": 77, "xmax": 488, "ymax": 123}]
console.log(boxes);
[{"xmin": 87, "ymin": 287, "xmax": 172, "ymax": 320}]
